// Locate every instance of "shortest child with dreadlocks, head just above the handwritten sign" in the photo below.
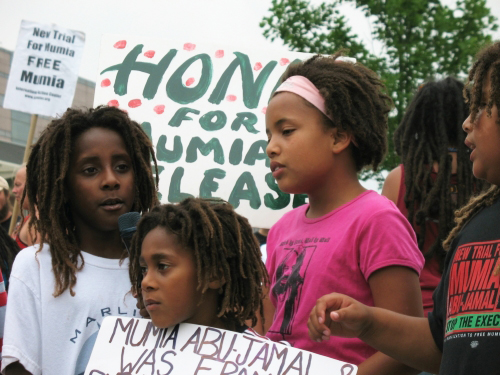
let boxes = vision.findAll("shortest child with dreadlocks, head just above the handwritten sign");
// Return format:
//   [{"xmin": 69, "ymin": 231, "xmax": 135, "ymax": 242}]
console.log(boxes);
[{"xmin": 130, "ymin": 198, "xmax": 267, "ymax": 333}]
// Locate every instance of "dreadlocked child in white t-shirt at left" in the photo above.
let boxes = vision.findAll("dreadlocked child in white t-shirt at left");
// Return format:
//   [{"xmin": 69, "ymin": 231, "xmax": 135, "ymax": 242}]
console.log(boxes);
[{"xmin": 2, "ymin": 107, "xmax": 157, "ymax": 375}]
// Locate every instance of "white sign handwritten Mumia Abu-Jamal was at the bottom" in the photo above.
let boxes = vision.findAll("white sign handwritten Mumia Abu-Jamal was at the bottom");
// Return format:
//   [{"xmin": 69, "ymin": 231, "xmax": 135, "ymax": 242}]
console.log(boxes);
[{"xmin": 85, "ymin": 317, "xmax": 357, "ymax": 375}]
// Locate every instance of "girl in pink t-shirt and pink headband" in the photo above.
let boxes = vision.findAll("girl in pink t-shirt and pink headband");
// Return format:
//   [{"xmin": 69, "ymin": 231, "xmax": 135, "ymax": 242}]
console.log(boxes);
[{"xmin": 266, "ymin": 54, "xmax": 424, "ymax": 374}]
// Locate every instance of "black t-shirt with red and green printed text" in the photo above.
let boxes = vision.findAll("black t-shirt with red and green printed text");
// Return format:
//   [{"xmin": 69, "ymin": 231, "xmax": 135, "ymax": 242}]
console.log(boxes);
[{"xmin": 428, "ymin": 200, "xmax": 500, "ymax": 375}]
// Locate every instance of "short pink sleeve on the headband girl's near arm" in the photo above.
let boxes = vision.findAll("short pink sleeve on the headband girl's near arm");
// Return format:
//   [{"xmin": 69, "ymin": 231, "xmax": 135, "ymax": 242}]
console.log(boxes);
[{"xmin": 358, "ymin": 209, "xmax": 425, "ymax": 280}]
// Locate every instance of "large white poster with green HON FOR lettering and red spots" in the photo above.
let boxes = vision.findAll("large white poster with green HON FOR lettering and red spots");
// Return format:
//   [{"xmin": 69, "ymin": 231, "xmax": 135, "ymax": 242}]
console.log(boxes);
[{"xmin": 94, "ymin": 35, "xmax": 312, "ymax": 228}]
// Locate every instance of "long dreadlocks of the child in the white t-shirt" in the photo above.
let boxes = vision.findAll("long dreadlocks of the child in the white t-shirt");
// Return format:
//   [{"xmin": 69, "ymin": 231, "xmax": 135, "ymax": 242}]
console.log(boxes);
[{"xmin": 21, "ymin": 106, "xmax": 158, "ymax": 297}]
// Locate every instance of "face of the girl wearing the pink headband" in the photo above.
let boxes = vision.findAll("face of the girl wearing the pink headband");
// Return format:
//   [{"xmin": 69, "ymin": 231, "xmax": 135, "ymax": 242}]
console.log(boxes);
[{"xmin": 266, "ymin": 92, "xmax": 334, "ymax": 195}]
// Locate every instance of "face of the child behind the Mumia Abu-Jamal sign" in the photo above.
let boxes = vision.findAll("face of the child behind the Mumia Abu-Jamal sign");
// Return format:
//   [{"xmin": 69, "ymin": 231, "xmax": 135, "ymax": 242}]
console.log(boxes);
[{"xmin": 139, "ymin": 227, "xmax": 217, "ymax": 328}]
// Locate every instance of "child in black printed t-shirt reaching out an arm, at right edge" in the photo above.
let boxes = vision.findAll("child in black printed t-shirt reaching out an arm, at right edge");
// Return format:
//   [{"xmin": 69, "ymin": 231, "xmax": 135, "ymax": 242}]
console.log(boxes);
[{"xmin": 309, "ymin": 42, "xmax": 500, "ymax": 375}]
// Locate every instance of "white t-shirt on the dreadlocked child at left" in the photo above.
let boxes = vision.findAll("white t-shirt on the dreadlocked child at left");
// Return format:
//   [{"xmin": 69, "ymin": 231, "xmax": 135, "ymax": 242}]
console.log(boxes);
[{"xmin": 2, "ymin": 245, "xmax": 140, "ymax": 375}]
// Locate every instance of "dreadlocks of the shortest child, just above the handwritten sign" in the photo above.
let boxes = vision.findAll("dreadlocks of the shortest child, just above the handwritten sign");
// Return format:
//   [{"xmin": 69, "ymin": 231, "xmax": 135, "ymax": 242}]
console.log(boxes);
[{"xmin": 129, "ymin": 198, "xmax": 268, "ymax": 326}]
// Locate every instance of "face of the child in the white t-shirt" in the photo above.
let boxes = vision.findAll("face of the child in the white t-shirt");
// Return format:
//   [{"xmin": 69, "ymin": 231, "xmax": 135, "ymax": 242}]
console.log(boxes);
[{"xmin": 67, "ymin": 127, "xmax": 135, "ymax": 235}]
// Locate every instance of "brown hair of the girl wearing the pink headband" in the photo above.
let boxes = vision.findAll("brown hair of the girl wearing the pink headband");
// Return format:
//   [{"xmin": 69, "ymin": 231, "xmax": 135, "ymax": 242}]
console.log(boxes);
[{"xmin": 282, "ymin": 51, "xmax": 392, "ymax": 171}]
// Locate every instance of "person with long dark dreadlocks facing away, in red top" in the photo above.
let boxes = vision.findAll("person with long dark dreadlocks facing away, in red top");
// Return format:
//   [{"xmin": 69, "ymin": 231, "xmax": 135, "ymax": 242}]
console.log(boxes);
[{"xmin": 382, "ymin": 77, "xmax": 482, "ymax": 316}]
